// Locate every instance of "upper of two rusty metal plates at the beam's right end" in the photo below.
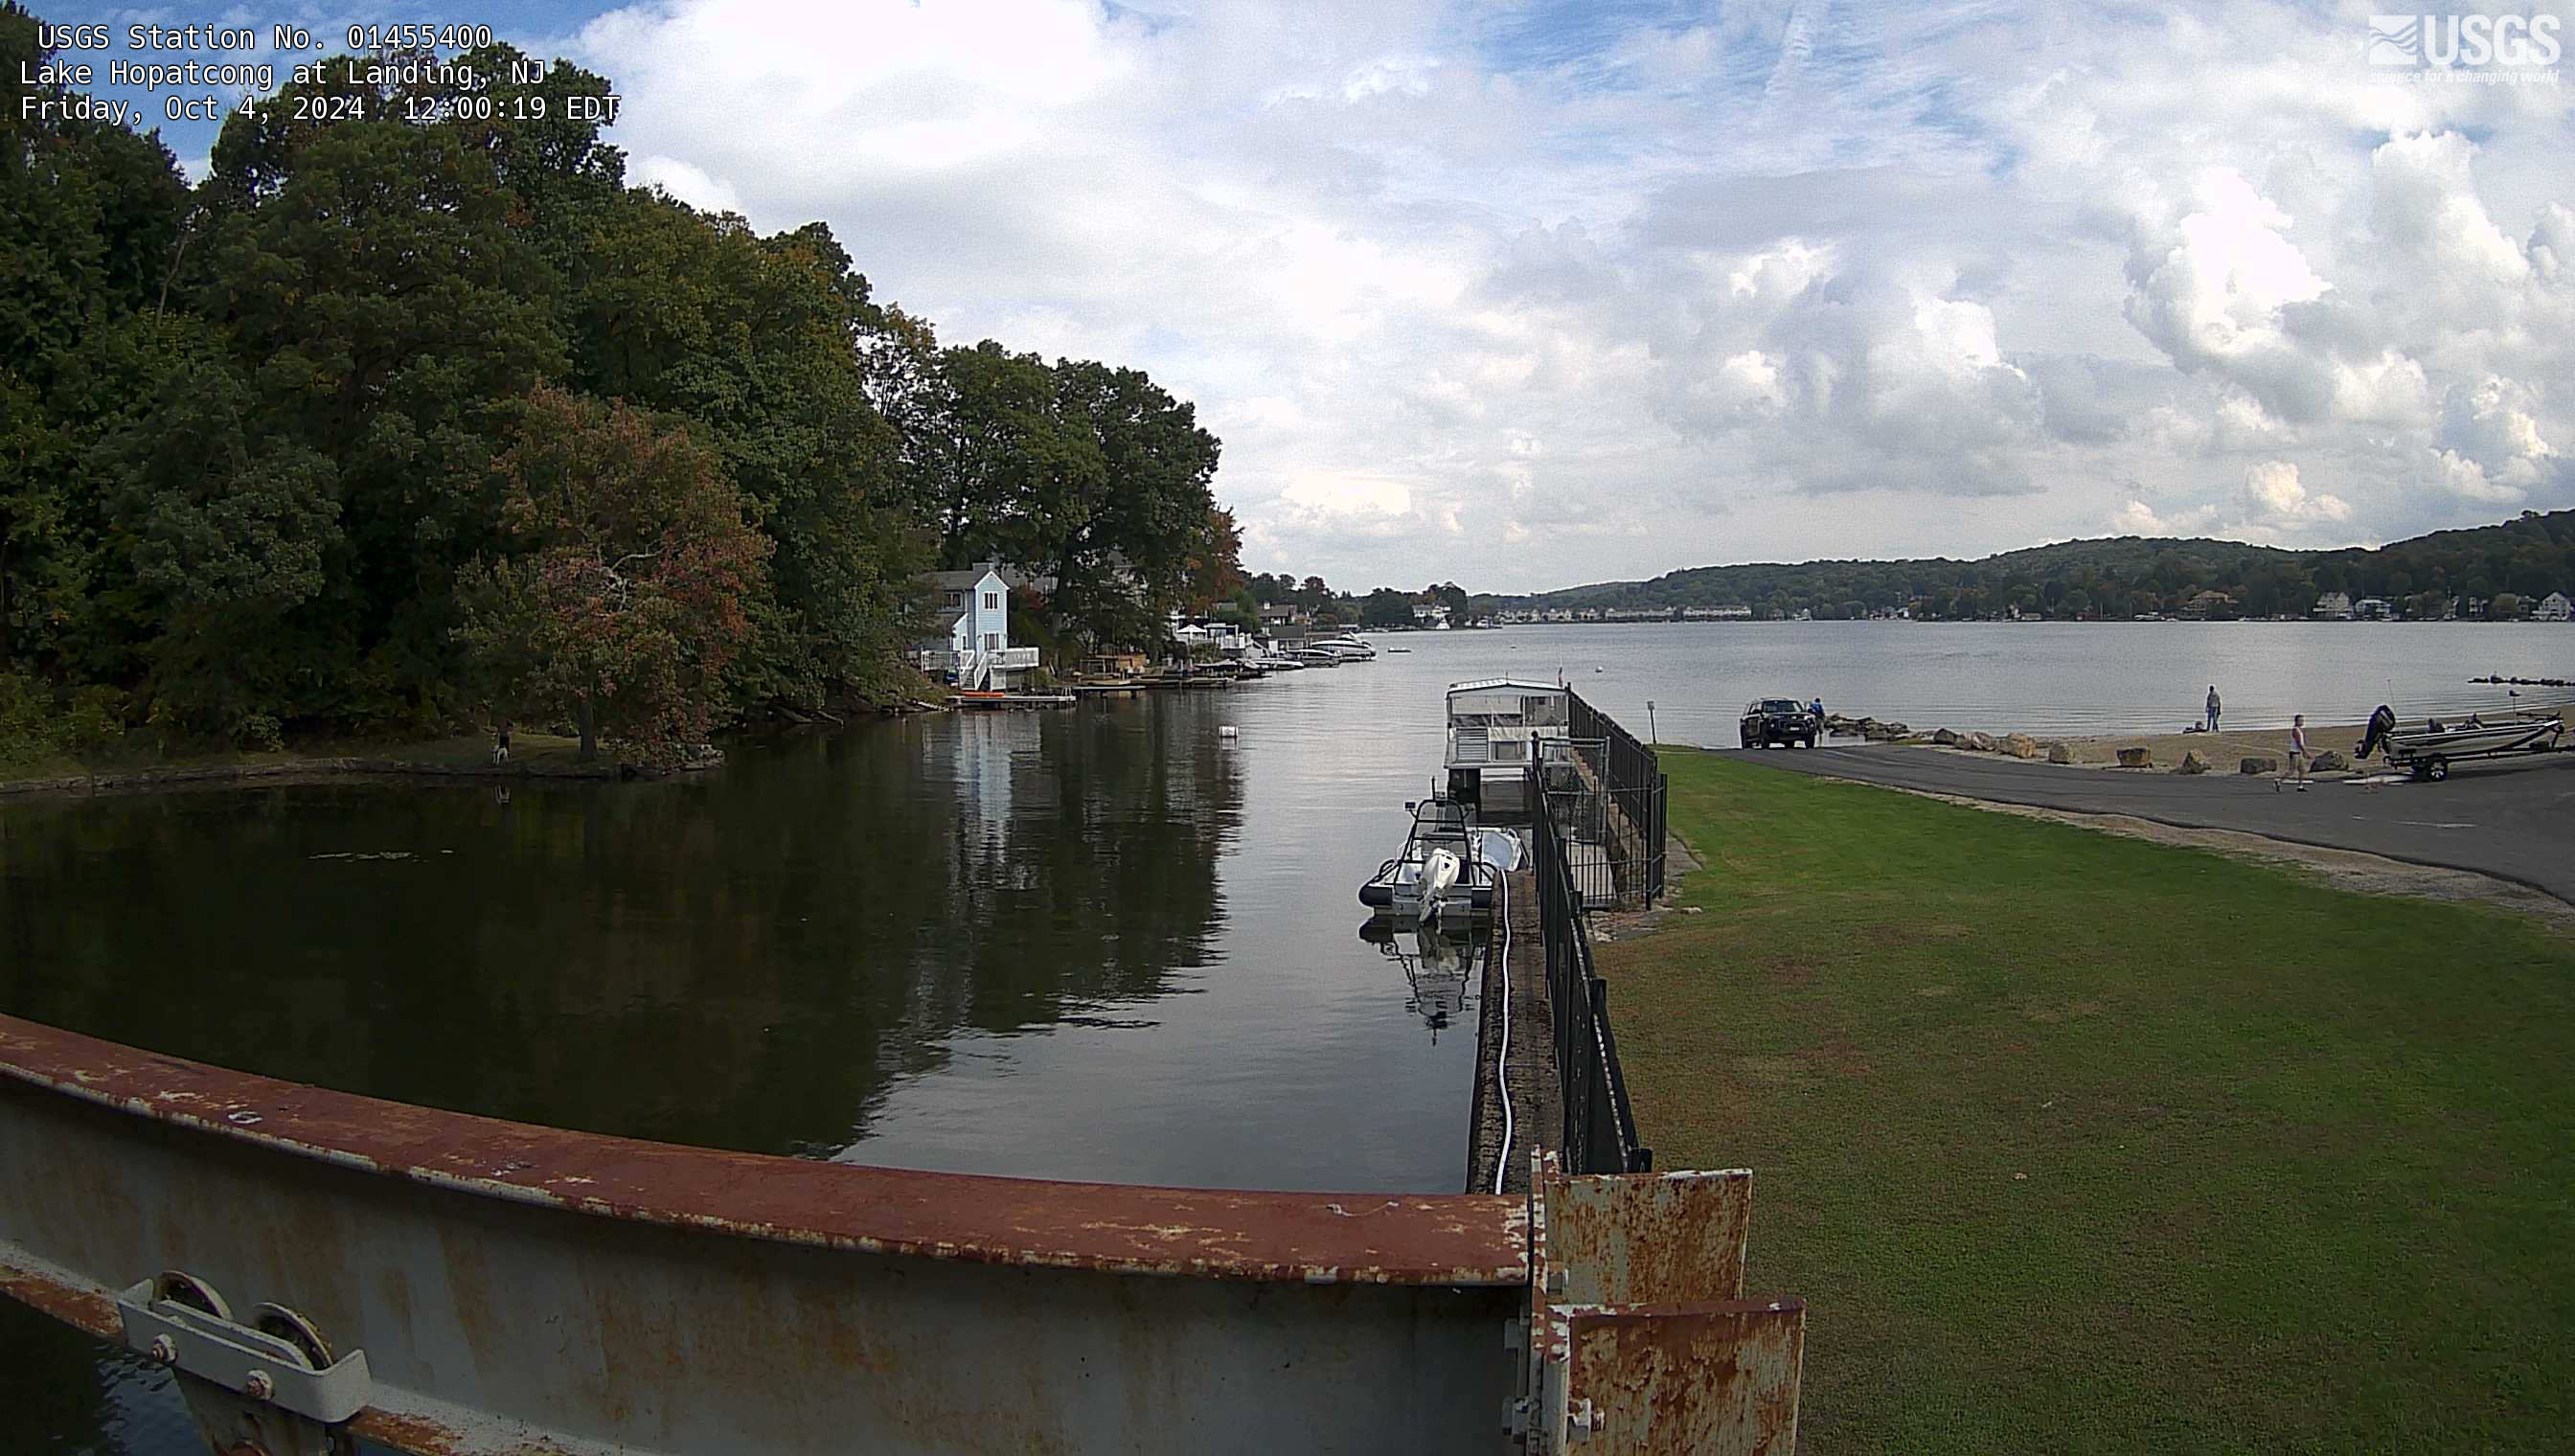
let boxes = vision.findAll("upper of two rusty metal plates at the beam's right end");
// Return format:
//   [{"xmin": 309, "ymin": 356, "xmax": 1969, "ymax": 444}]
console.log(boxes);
[{"xmin": 1542, "ymin": 1168, "xmax": 1754, "ymax": 1304}]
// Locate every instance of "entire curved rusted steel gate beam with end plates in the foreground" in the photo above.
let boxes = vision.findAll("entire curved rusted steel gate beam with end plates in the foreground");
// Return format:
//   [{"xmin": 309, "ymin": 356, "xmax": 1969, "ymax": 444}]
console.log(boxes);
[{"xmin": 0, "ymin": 1018, "xmax": 1805, "ymax": 1456}]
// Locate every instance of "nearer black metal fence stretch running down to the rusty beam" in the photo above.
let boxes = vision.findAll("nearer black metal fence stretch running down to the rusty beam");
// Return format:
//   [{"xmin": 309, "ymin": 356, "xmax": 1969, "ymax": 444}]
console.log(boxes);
[{"xmin": 1530, "ymin": 778, "xmax": 1653, "ymax": 1172}]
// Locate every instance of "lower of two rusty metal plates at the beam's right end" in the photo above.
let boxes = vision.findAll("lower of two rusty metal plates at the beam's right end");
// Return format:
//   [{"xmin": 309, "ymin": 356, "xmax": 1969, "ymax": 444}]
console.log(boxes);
[{"xmin": 1565, "ymin": 1299, "xmax": 1805, "ymax": 1456}]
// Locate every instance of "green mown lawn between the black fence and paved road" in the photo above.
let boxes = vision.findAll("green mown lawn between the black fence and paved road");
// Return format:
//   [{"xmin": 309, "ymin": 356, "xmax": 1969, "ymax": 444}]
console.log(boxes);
[{"xmin": 1599, "ymin": 747, "xmax": 2575, "ymax": 1453}]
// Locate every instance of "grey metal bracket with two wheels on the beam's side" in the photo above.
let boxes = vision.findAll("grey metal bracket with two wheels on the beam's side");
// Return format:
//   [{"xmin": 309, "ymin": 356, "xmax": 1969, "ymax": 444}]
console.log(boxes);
[{"xmin": 116, "ymin": 1270, "xmax": 368, "ymax": 1456}]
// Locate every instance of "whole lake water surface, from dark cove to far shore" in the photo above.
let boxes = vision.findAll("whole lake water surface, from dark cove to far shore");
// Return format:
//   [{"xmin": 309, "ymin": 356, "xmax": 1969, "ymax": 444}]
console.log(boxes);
[{"xmin": 0, "ymin": 624, "xmax": 2575, "ymax": 1456}]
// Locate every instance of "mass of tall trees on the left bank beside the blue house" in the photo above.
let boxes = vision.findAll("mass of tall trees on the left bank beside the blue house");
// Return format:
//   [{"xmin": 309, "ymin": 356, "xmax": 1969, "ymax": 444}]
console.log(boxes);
[{"xmin": 0, "ymin": 0, "xmax": 1242, "ymax": 755}]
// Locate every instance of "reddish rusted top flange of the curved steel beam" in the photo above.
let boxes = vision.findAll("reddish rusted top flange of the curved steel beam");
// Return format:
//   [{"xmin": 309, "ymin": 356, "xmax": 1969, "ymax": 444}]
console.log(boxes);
[{"xmin": 0, "ymin": 1018, "xmax": 1527, "ymax": 1285}]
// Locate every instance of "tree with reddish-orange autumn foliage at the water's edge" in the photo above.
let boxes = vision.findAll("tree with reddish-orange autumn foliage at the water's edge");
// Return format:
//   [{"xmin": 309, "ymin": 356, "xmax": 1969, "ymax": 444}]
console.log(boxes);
[{"xmin": 458, "ymin": 389, "xmax": 770, "ymax": 762}]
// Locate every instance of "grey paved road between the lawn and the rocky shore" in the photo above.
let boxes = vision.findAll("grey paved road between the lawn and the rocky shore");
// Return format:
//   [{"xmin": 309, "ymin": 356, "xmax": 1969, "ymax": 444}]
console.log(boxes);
[{"xmin": 1720, "ymin": 744, "xmax": 2575, "ymax": 902}]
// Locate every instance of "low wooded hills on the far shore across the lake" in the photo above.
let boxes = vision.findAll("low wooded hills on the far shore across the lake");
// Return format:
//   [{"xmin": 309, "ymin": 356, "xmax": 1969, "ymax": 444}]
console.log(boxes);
[{"xmin": 1475, "ymin": 511, "xmax": 2575, "ymax": 621}]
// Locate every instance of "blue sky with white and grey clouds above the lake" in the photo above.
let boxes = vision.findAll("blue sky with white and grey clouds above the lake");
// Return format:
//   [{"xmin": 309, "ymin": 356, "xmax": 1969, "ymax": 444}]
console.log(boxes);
[{"xmin": 38, "ymin": 0, "xmax": 2575, "ymax": 593}]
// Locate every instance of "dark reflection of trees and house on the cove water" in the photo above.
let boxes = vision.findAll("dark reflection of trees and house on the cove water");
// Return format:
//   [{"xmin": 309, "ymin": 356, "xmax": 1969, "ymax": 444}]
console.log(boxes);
[{"xmin": 0, "ymin": 712, "xmax": 1242, "ymax": 1152}]
